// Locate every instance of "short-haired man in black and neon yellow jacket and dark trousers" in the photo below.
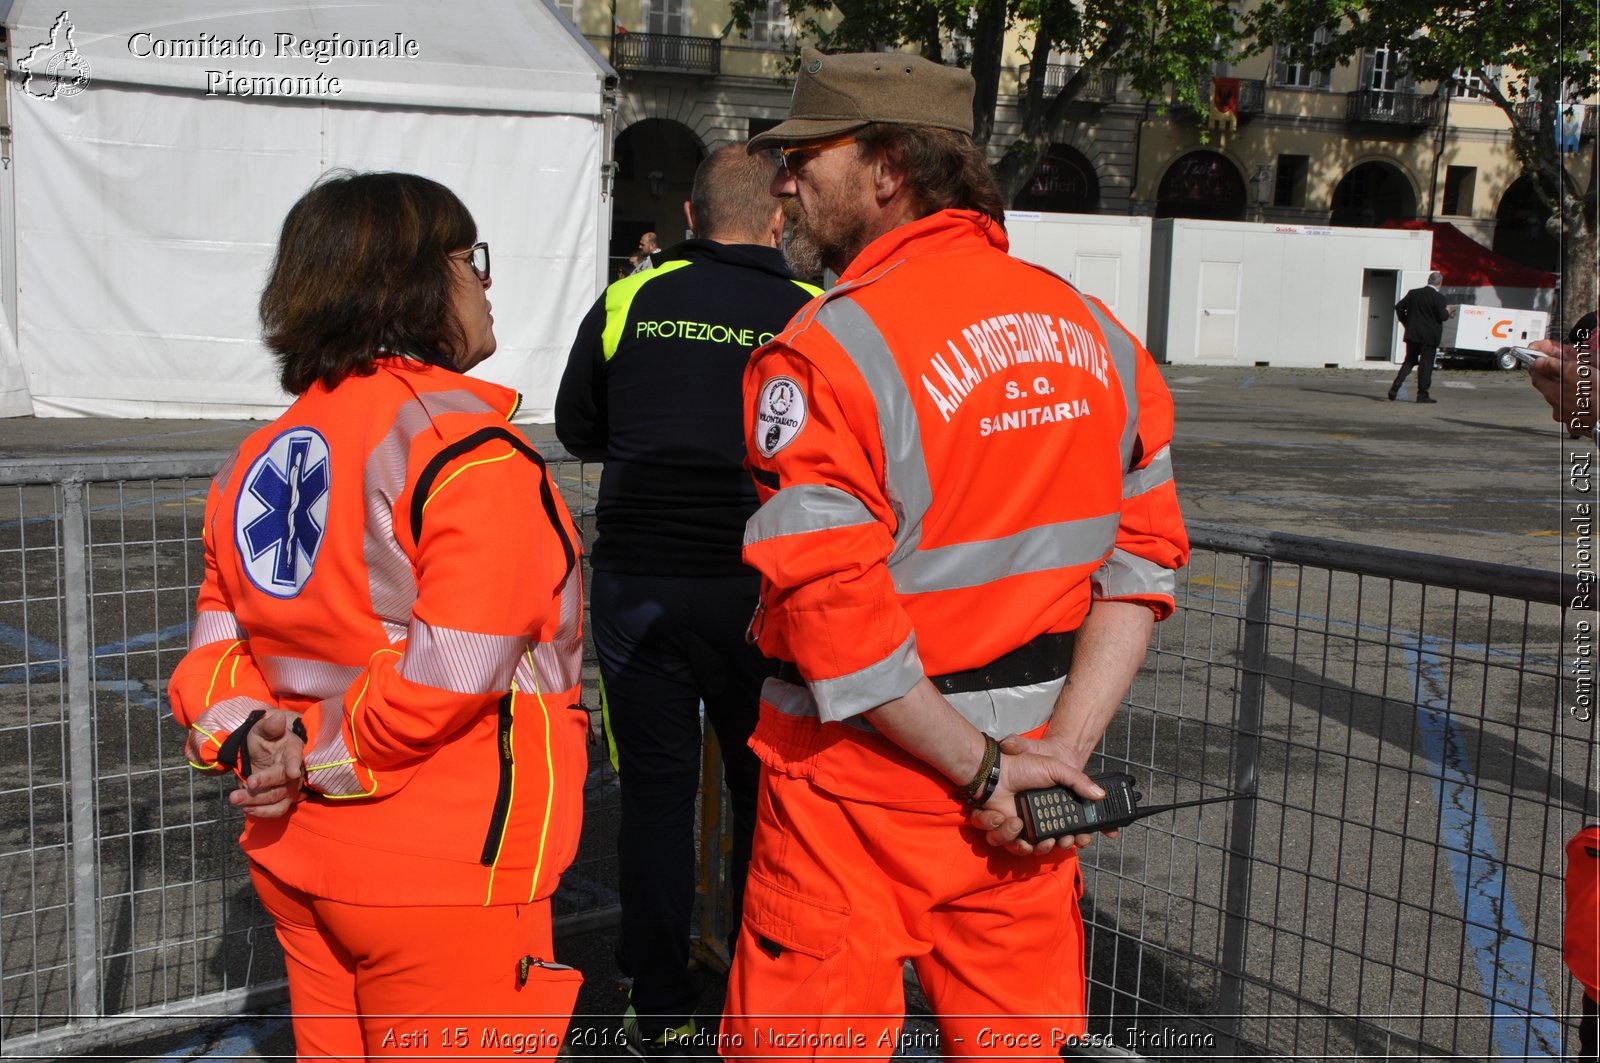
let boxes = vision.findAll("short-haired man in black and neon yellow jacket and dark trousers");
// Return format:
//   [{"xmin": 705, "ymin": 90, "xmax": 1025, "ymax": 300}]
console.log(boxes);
[{"xmin": 555, "ymin": 144, "xmax": 819, "ymax": 1055}]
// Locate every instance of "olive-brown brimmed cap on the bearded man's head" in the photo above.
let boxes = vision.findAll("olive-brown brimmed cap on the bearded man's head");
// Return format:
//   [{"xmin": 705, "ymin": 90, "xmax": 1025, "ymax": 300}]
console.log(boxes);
[{"xmin": 747, "ymin": 48, "xmax": 974, "ymax": 154}]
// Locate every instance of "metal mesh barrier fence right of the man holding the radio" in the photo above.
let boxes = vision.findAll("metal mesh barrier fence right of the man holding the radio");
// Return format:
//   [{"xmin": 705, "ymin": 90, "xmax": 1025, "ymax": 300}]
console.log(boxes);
[{"xmin": 1085, "ymin": 525, "xmax": 1597, "ymax": 1060}]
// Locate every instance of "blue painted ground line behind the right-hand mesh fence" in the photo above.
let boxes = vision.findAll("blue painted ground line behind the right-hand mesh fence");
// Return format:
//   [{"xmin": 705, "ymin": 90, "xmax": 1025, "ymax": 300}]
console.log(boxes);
[{"xmin": 1406, "ymin": 639, "xmax": 1562, "ymax": 1060}]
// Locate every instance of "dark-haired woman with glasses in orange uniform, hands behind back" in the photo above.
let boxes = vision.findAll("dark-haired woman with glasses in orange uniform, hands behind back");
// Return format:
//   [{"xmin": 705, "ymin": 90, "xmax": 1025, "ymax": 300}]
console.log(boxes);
[{"xmin": 170, "ymin": 173, "xmax": 587, "ymax": 1060}]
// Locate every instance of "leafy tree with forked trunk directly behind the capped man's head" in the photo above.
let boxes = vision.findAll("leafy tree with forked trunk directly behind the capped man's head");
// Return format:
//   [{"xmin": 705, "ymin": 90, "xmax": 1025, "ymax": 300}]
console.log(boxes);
[{"xmin": 733, "ymin": 0, "xmax": 1237, "ymax": 203}]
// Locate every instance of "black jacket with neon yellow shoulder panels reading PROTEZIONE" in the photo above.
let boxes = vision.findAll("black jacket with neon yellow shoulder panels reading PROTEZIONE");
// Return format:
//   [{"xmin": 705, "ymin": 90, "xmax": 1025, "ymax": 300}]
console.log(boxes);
[{"xmin": 555, "ymin": 240, "xmax": 819, "ymax": 576}]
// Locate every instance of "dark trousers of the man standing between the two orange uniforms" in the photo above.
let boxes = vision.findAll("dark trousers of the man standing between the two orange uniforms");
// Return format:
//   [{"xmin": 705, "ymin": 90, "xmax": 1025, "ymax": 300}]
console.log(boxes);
[{"xmin": 590, "ymin": 572, "xmax": 776, "ymax": 1037}]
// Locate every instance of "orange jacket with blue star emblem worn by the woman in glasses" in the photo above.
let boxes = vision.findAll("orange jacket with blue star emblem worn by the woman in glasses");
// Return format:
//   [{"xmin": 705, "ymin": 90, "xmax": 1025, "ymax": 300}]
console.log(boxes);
[{"xmin": 170, "ymin": 357, "xmax": 587, "ymax": 905}]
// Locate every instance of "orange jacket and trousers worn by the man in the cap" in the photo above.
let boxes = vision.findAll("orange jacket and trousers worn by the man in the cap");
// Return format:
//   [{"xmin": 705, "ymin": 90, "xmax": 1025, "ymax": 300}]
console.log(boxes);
[{"xmin": 722, "ymin": 211, "xmax": 1189, "ymax": 1058}]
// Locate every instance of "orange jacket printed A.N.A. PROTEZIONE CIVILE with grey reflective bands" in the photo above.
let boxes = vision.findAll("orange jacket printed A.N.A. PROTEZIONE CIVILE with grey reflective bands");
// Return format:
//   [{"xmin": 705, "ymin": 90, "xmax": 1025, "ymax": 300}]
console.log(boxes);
[{"xmin": 744, "ymin": 211, "xmax": 1189, "ymax": 781}]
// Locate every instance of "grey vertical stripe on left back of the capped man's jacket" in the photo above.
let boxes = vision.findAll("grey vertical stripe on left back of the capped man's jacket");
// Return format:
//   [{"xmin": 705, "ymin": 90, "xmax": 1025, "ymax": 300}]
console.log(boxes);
[{"xmin": 816, "ymin": 298, "xmax": 933, "ymax": 560}]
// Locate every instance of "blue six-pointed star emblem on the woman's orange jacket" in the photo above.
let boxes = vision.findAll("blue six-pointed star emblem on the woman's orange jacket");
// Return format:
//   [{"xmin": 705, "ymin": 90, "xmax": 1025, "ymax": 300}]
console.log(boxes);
[{"xmin": 234, "ymin": 427, "xmax": 330, "ymax": 599}]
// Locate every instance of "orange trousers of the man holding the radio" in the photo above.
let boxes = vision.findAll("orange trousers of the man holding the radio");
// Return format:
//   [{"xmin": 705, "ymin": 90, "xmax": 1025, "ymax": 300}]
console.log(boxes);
[{"xmin": 720, "ymin": 770, "xmax": 1085, "ymax": 1060}]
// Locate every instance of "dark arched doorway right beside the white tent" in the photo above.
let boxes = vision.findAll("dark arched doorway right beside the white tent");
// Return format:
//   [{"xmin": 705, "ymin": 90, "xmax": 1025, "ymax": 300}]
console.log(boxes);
[{"xmin": 611, "ymin": 118, "xmax": 706, "ymax": 277}]
